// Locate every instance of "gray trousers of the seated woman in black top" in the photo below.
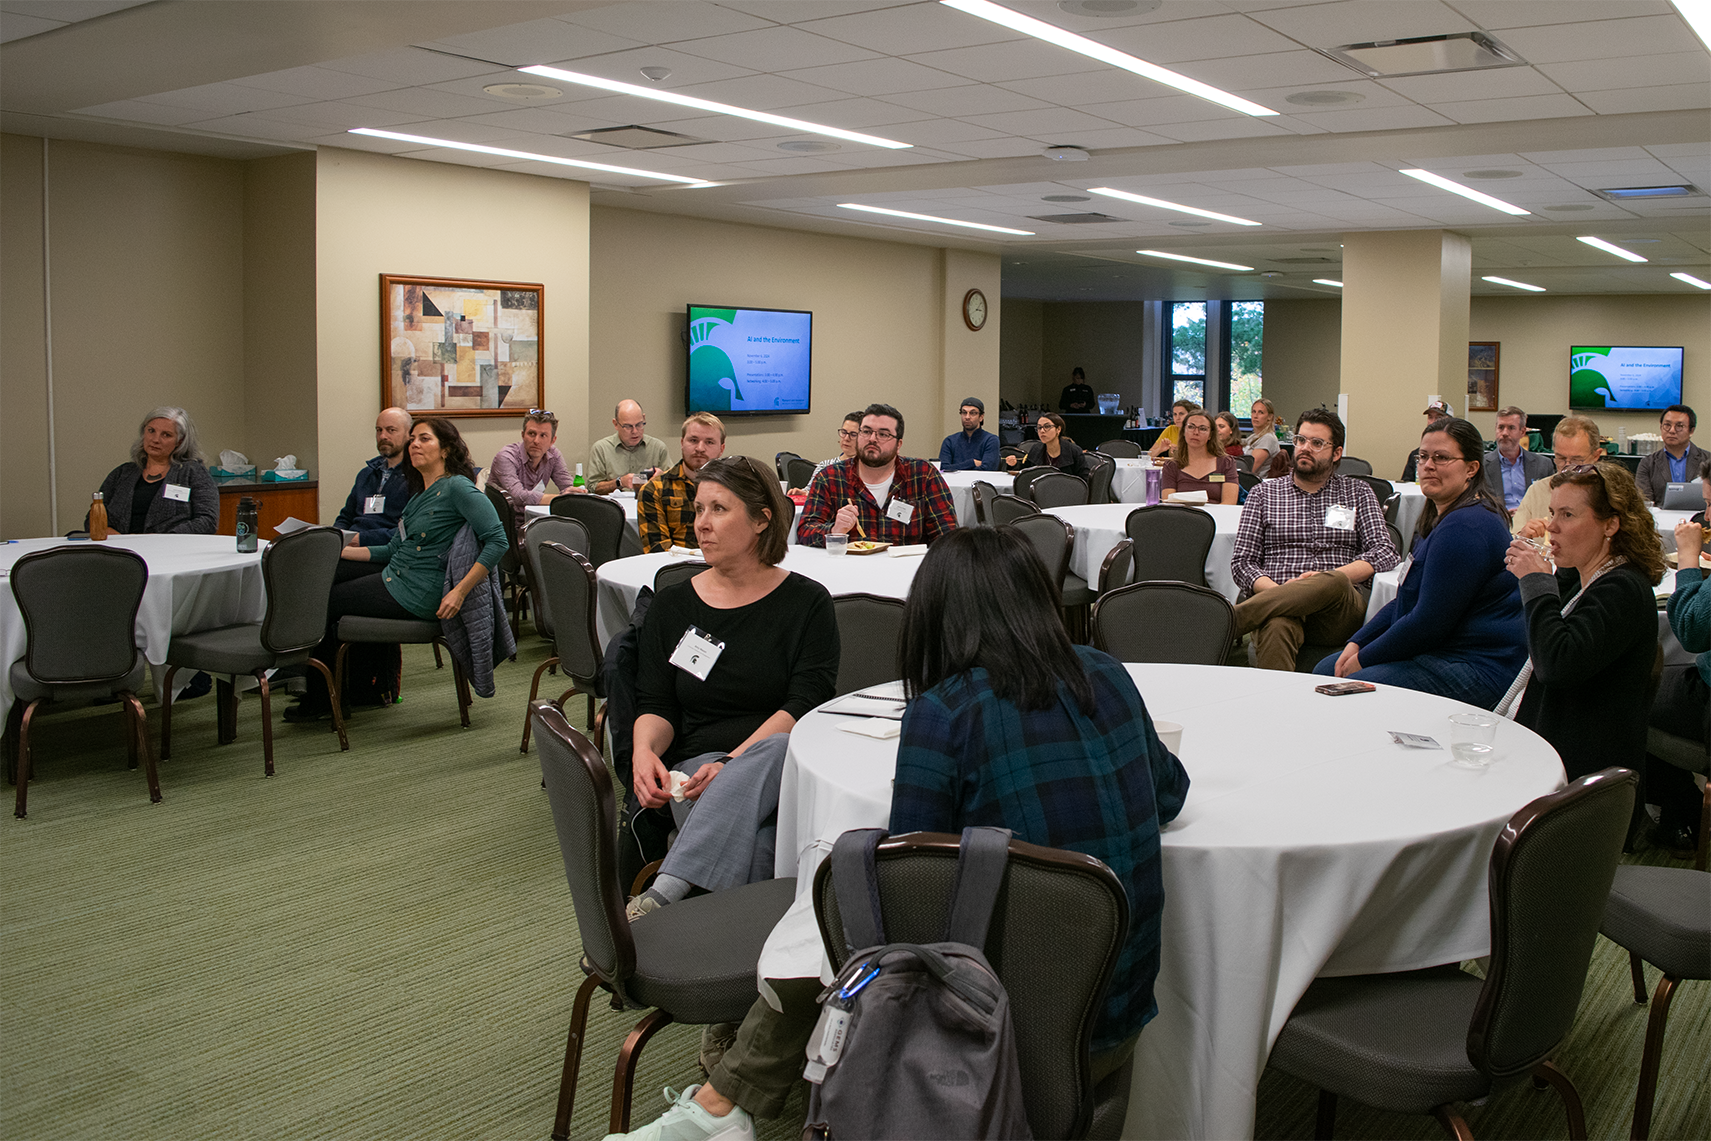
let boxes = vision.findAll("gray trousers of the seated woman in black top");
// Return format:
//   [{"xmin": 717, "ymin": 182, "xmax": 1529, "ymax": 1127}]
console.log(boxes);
[{"xmin": 659, "ymin": 732, "xmax": 790, "ymax": 891}]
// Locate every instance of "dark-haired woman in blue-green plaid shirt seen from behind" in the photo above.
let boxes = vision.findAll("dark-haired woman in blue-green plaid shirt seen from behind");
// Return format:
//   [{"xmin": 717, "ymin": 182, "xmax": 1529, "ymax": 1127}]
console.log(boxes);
[{"xmin": 891, "ymin": 527, "xmax": 1187, "ymax": 1081}]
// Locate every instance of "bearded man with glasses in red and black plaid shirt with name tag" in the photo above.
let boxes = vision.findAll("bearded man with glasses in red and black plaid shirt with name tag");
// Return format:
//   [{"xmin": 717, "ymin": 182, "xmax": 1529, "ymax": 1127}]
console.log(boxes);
[{"xmin": 796, "ymin": 404, "xmax": 956, "ymax": 547}]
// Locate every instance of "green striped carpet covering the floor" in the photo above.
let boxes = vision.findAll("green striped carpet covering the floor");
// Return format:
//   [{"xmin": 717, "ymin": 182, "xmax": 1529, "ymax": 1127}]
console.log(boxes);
[{"xmin": 0, "ymin": 631, "xmax": 1711, "ymax": 1141}]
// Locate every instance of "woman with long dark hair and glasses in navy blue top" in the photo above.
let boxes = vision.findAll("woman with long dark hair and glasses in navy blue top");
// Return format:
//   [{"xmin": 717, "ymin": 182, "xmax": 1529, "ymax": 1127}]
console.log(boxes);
[{"xmin": 1314, "ymin": 417, "xmax": 1526, "ymax": 708}]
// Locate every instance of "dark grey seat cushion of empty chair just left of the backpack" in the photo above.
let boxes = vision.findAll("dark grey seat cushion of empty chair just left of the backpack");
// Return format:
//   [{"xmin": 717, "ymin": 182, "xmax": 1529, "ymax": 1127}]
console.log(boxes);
[{"xmin": 628, "ymin": 878, "xmax": 796, "ymax": 1025}]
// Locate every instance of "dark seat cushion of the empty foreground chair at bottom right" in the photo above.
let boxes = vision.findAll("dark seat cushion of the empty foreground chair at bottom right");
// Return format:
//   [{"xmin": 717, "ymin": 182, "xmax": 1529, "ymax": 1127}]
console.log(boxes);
[{"xmin": 1271, "ymin": 967, "xmax": 1490, "ymax": 1114}]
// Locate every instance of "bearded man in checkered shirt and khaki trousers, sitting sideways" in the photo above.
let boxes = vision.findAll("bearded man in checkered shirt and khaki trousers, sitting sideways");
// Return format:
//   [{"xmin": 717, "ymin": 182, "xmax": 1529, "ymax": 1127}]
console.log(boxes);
[{"xmin": 1230, "ymin": 409, "xmax": 1401, "ymax": 671}]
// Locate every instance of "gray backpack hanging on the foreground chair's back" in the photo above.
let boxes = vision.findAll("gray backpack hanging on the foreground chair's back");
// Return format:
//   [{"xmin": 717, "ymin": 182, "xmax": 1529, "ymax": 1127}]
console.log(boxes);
[{"xmin": 802, "ymin": 828, "xmax": 1033, "ymax": 1141}]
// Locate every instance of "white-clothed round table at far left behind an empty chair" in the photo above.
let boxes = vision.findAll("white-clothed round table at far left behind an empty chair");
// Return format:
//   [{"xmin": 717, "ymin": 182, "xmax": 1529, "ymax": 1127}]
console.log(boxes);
[{"xmin": 0, "ymin": 535, "xmax": 267, "ymax": 717}]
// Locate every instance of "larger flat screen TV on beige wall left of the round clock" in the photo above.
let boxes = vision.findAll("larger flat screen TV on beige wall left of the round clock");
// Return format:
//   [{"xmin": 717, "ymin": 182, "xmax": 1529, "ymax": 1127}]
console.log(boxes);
[{"xmin": 684, "ymin": 304, "xmax": 814, "ymax": 416}]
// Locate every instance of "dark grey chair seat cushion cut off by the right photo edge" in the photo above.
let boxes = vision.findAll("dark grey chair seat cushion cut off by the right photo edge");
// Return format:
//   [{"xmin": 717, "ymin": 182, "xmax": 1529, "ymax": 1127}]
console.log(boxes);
[{"xmin": 1600, "ymin": 866, "xmax": 1711, "ymax": 978}]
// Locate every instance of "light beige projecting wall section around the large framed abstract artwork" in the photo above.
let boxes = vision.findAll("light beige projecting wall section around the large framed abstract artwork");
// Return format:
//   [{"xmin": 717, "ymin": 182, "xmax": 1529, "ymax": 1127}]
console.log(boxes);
[{"xmin": 315, "ymin": 147, "xmax": 588, "ymax": 522}]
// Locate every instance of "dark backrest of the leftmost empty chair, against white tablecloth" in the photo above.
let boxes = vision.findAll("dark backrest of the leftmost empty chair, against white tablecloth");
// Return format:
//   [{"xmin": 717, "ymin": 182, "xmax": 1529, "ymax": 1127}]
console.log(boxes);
[{"xmin": 10, "ymin": 544, "xmax": 149, "ymax": 684}]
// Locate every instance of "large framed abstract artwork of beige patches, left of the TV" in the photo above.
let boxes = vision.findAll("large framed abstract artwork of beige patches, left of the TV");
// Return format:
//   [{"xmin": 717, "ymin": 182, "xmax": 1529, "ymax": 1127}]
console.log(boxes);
[{"xmin": 380, "ymin": 274, "xmax": 546, "ymax": 417}]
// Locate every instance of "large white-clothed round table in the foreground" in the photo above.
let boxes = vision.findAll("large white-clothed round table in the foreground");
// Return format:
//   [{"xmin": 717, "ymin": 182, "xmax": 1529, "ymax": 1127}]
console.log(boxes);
[{"xmin": 758, "ymin": 665, "xmax": 1564, "ymax": 1141}]
